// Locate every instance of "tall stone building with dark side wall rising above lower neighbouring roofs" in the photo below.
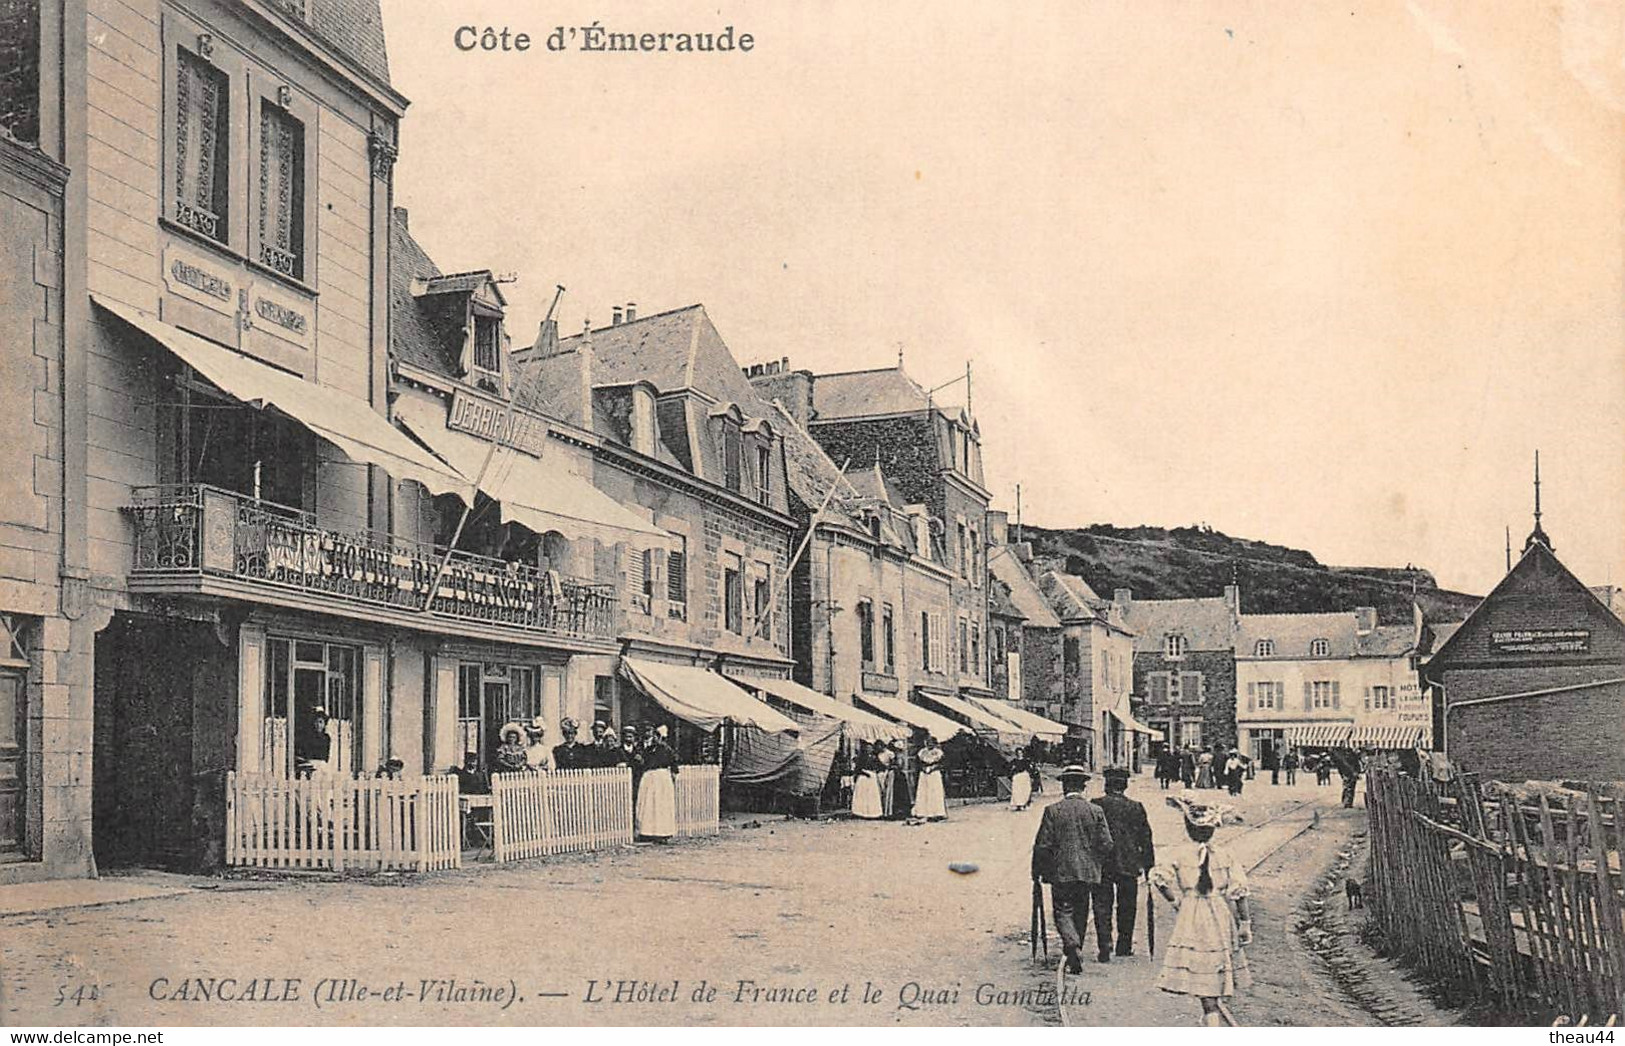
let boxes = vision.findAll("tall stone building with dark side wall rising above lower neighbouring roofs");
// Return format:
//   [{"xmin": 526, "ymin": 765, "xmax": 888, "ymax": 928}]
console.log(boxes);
[{"xmin": 749, "ymin": 361, "xmax": 993, "ymax": 708}]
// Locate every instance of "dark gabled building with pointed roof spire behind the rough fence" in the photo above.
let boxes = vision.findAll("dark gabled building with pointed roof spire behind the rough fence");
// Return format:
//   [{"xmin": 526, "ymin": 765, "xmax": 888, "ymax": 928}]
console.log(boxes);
[{"xmin": 1424, "ymin": 519, "xmax": 1625, "ymax": 781}]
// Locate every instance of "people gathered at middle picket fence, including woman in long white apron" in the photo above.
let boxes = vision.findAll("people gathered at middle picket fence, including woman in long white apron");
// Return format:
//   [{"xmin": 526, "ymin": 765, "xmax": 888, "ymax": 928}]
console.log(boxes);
[{"xmin": 457, "ymin": 716, "xmax": 679, "ymax": 843}]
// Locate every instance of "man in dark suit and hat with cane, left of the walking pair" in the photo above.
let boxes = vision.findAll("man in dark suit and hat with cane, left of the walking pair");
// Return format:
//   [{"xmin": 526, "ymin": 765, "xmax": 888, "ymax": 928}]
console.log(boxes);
[{"xmin": 1032, "ymin": 765, "xmax": 1112, "ymax": 973}]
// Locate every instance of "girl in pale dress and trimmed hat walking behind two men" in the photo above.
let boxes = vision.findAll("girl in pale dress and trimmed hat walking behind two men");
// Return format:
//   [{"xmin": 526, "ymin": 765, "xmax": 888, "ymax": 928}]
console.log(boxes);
[{"xmin": 1151, "ymin": 794, "xmax": 1253, "ymax": 1028}]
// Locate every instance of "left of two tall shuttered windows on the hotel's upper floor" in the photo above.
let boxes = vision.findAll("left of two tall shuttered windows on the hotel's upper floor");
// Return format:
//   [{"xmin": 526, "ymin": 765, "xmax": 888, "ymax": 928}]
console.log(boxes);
[{"xmin": 172, "ymin": 45, "xmax": 231, "ymax": 244}]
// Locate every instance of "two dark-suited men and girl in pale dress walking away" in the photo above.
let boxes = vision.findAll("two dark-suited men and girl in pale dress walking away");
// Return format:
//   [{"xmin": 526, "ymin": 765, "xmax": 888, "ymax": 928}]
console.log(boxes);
[{"xmin": 1032, "ymin": 765, "xmax": 1253, "ymax": 1027}]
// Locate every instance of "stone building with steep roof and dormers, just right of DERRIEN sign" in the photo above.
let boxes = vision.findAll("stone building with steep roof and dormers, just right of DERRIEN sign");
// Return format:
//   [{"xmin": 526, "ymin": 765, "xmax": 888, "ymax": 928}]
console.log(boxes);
[{"xmin": 515, "ymin": 305, "xmax": 796, "ymax": 744}]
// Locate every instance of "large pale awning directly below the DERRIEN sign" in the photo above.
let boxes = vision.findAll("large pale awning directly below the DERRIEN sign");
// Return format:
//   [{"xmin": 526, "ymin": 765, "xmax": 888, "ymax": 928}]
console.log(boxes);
[{"xmin": 395, "ymin": 396, "xmax": 673, "ymax": 546}]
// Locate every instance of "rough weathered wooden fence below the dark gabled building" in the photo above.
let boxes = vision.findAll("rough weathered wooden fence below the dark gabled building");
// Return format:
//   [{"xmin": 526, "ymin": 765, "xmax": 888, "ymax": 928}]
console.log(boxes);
[{"xmin": 1367, "ymin": 770, "xmax": 1625, "ymax": 1023}]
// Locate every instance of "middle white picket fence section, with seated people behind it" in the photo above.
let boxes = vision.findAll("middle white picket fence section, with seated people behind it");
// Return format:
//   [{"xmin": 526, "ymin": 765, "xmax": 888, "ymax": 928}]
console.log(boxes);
[{"xmin": 491, "ymin": 767, "xmax": 632, "ymax": 861}]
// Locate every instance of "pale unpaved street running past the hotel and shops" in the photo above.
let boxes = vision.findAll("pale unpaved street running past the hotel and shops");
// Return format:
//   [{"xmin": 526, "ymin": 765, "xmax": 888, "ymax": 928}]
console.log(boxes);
[{"xmin": 0, "ymin": 778, "xmax": 1449, "ymax": 1027}]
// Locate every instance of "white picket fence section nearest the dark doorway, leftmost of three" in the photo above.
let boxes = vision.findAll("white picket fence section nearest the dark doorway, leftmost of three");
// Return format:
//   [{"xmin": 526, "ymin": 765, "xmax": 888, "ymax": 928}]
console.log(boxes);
[{"xmin": 226, "ymin": 772, "xmax": 462, "ymax": 872}]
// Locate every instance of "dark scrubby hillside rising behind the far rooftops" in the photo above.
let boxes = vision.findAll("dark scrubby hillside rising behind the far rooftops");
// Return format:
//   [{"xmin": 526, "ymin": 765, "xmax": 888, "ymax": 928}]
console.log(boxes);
[{"xmin": 1022, "ymin": 523, "xmax": 1479, "ymax": 624}]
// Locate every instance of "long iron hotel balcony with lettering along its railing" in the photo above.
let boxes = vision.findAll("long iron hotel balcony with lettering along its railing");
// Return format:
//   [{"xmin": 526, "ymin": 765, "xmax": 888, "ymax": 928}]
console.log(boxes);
[{"xmin": 125, "ymin": 484, "xmax": 618, "ymax": 643}]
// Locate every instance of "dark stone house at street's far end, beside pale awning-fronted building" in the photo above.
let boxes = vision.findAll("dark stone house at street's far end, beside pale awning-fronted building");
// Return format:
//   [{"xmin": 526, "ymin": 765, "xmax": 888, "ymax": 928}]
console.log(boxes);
[{"xmin": 1112, "ymin": 585, "xmax": 1242, "ymax": 752}]
